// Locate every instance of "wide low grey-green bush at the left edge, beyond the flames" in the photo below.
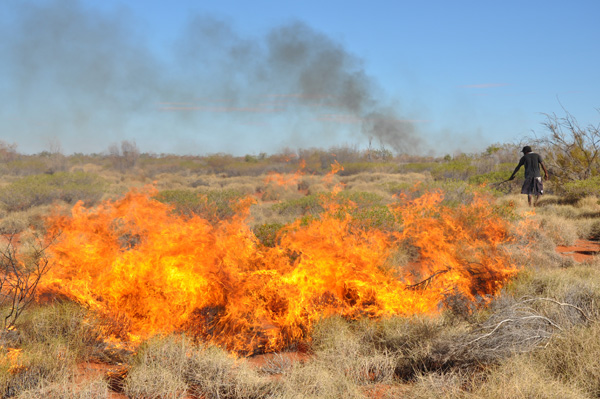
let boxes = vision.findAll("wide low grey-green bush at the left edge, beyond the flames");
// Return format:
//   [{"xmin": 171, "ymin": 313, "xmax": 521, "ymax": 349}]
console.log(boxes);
[{"xmin": 0, "ymin": 172, "xmax": 106, "ymax": 212}]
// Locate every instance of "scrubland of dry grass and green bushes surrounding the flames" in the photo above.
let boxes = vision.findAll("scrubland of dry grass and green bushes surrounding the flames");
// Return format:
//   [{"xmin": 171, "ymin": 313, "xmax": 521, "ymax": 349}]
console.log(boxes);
[{"xmin": 0, "ymin": 130, "xmax": 600, "ymax": 399}]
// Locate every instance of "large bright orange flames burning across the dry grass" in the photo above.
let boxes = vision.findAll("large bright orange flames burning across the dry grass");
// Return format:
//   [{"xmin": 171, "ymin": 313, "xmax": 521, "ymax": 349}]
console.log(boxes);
[{"xmin": 40, "ymin": 186, "xmax": 515, "ymax": 354}]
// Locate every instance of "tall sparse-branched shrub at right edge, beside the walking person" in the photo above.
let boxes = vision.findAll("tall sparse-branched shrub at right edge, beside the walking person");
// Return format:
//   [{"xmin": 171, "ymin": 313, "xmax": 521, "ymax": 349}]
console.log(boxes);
[{"xmin": 540, "ymin": 110, "xmax": 600, "ymax": 187}]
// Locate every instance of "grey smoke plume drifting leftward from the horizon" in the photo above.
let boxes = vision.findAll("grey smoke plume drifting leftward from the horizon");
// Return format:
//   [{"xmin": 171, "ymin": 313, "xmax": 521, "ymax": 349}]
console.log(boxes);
[{"xmin": 0, "ymin": 0, "xmax": 419, "ymax": 153}]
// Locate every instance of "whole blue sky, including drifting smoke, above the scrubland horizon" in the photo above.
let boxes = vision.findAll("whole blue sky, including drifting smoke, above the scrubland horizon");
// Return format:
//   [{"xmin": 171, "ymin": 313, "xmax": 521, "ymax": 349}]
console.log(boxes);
[{"xmin": 0, "ymin": 0, "xmax": 600, "ymax": 155}]
